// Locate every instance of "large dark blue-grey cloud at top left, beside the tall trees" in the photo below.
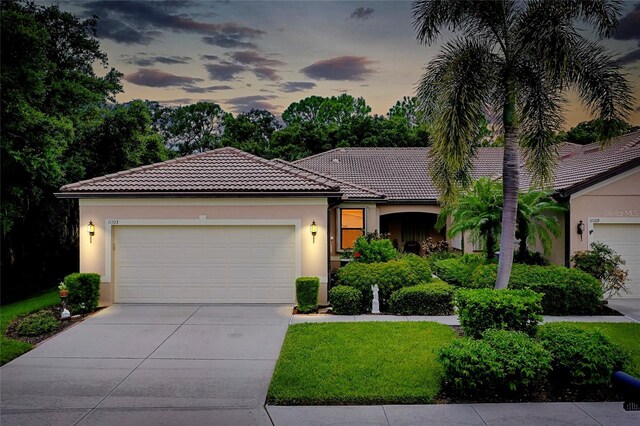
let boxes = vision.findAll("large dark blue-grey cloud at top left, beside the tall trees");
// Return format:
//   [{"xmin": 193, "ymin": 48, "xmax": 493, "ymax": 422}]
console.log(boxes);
[{"xmin": 82, "ymin": 0, "xmax": 265, "ymax": 44}]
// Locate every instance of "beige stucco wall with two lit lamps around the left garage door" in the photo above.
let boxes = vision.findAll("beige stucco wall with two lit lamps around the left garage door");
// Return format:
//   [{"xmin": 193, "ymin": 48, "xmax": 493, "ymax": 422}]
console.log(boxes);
[{"xmin": 79, "ymin": 198, "xmax": 328, "ymax": 305}]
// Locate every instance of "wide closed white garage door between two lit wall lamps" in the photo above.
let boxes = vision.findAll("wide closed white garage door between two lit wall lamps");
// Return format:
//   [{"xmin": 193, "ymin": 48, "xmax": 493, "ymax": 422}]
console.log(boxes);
[{"xmin": 113, "ymin": 226, "xmax": 295, "ymax": 303}]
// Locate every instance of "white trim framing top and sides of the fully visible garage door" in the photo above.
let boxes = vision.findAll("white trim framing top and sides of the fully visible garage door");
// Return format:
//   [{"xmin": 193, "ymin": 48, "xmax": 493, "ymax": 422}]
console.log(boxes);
[{"xmin": 100, "ymin": 215, "xmax": 302, "ymax": 282}]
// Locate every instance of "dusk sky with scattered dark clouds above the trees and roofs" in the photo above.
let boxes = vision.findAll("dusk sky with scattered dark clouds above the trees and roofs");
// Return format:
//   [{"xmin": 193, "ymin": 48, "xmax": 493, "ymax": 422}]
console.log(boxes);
[{"xmin": 59, "ymin": 0, "xmax": 640, "ymax": 127}]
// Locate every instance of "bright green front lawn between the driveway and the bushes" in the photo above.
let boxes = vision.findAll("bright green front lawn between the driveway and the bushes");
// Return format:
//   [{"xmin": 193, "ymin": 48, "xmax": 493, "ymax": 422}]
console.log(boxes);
[{"xmin": 267, "ymin": 322, "xmax": 456, "ymax": 405}]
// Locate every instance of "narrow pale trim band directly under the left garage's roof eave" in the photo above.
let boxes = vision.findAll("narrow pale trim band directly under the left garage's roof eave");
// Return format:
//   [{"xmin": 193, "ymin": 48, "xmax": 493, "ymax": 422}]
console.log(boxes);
[{"xmin": 80, "ymin": 197, "xmax": 327, "ymax": 206}]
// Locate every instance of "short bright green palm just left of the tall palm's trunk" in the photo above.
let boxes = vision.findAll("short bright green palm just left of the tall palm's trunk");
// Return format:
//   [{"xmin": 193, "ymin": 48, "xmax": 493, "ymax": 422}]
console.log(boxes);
[{"xmin": 436, "ymin": 177, "xmax": 502, "ymax": 259}]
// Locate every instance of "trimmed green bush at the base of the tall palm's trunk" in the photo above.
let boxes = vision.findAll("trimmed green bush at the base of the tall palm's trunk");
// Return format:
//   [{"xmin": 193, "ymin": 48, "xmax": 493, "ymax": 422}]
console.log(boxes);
[{"xmin": 455, "ymin": 289, "xmax": 542, "ymax": 338}]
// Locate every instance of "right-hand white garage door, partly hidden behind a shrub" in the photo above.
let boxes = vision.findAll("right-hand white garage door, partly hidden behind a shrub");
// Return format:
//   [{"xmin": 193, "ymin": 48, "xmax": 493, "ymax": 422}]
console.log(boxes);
[{"xmin": 591, "ymin": 223, "xmax": 640, "ymax": 299}]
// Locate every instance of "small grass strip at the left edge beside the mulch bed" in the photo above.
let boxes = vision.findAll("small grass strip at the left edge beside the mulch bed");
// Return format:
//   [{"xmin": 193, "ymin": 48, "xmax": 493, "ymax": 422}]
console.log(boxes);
[{"xmin": 0, "ymin": 289, "xmax": 60, "ymax": 365}]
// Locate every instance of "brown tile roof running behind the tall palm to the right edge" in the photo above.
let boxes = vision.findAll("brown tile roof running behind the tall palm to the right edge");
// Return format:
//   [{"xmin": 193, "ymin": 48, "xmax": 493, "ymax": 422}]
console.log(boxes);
[{"xmin": 293, "ymin": 131, "xmax": 640, "ymax": 202}]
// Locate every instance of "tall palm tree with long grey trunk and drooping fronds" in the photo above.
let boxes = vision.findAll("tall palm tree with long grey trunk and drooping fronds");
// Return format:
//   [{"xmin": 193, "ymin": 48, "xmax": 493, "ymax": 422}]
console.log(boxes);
[{"xmin": 412, "ymin": 0, "xmax": 632, "ymax": 288}]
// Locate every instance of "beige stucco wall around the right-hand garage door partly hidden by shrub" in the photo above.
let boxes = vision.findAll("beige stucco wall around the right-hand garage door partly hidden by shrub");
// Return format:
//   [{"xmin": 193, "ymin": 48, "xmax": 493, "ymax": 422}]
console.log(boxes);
[{"xmin": 569, "ymin": 167, "xmax": 640, "ymax": 255}]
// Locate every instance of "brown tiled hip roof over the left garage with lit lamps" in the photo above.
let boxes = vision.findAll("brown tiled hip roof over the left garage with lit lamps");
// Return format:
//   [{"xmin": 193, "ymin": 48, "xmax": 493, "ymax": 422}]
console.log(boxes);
[{"xmin": 60, "ymin": 147, "xmax": 340, "ymax": 196}]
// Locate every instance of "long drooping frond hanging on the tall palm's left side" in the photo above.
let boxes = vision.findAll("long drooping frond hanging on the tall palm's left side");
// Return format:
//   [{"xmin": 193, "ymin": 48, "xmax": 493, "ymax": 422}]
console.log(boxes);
[{"xmin": 417, "ymin": 39, "xmax": 499, "ymax": 204}]
